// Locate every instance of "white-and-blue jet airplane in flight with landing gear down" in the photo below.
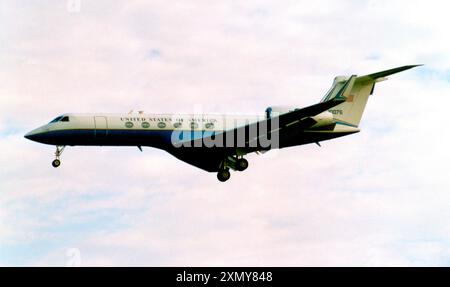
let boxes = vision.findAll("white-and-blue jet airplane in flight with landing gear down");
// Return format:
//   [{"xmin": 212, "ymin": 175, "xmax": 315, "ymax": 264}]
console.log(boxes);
[{"xmin": 25, "ymin": 65, "xmax": 421, "ymax": 182}]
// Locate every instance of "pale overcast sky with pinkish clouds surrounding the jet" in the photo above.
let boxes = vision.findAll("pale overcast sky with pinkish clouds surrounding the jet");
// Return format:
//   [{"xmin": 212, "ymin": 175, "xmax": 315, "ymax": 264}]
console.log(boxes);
[{"xmin": 0, "ymin": 0, "xmax": 450, "ymax": 266}]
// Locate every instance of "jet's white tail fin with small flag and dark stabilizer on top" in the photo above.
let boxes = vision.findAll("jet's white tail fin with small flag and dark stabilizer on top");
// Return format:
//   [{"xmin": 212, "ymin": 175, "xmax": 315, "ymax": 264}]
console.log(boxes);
[{"xmin": 322, "ymin": 65, "xmax": 421, "ymax": 127}]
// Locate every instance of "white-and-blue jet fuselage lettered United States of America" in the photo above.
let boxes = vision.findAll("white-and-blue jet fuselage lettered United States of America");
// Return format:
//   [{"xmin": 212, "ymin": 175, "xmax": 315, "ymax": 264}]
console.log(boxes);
[{"xmin": 26, "ymin": 112, "xmax": 359, "ymax": 148}]
